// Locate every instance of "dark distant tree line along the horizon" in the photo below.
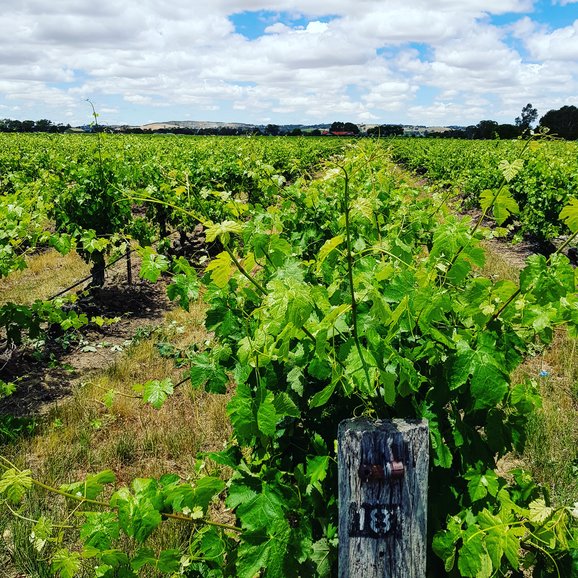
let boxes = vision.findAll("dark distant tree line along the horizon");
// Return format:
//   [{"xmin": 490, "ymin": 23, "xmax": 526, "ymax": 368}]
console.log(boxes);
[{"xmin": 0, "ymin": 103, "xmax": 578, "ymax": 140}]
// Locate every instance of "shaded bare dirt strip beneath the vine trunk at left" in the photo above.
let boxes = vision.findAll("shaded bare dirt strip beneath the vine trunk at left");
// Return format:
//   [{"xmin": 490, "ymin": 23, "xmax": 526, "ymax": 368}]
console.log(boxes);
[{"xmin": 0, "ymin": 259, "xmax": 172, "ymax": 417}]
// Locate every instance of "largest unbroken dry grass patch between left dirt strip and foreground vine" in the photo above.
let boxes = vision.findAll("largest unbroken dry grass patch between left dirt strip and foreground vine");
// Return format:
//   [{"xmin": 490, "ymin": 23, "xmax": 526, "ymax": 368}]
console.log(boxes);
[{"xmin": 12, "ymin": 307, "xmax": 230, "ymax": 484}]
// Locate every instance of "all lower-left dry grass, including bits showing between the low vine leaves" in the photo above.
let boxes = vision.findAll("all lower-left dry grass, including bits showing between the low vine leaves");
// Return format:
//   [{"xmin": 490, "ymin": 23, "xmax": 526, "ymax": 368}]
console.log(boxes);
[{"xmin": 0, "ymin": 304, "xmax": 231, "ymax": 577}]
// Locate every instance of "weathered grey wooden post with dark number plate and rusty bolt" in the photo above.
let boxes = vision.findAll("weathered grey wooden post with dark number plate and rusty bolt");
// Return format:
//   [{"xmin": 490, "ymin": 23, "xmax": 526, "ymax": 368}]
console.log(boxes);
[{"xmin": 338, "ymin": 418, "xmax": 429, "ymax": 578}]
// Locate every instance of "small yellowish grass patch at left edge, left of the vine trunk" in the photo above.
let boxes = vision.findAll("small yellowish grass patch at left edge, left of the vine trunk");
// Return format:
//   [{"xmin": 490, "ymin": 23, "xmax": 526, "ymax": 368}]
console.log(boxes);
[{"xmin": 0, "ymin": 249, "xmax": 90, "ymax": 305}]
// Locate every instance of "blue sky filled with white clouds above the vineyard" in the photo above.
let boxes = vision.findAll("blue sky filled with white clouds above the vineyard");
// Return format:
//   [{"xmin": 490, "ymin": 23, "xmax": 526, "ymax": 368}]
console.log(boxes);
[{"xmin": 0, "ymin": 0, "xmax": 578, "ymax": 125}]
